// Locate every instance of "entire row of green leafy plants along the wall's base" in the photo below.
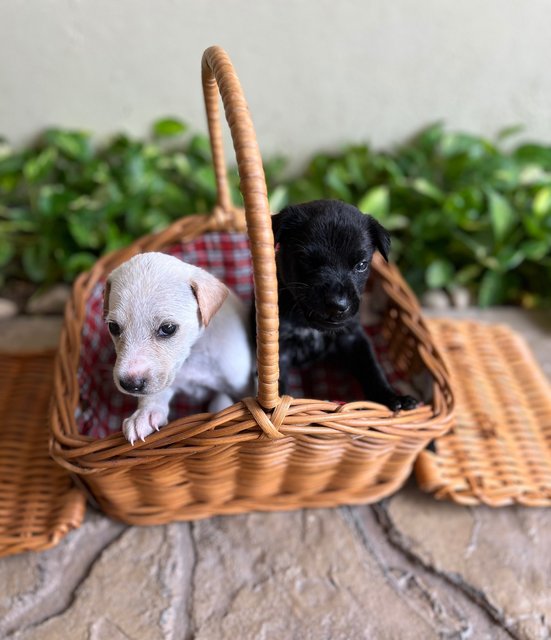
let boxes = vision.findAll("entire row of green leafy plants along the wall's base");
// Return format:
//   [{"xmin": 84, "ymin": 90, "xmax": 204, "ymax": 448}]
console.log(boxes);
[{"xmin": 0, "ymin": 118, "xmax": 551, "ymax": 307}]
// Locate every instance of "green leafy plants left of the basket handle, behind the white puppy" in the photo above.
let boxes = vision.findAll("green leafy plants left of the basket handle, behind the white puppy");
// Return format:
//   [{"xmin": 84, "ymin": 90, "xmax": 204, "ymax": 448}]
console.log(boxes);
[{"xmin": 0, "ymin": 118, "xmax": 280, "ymax": 284}]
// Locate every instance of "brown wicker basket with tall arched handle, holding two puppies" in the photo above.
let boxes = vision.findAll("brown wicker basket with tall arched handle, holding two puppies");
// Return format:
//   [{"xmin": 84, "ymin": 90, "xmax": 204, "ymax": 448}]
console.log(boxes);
[{"xmin": 50, "ymin": 47, "xmax": 453, "ymax": 524}]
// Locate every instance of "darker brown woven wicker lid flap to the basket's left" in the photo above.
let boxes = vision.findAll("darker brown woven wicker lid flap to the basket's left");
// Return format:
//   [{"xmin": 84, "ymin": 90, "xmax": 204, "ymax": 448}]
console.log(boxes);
[{"xmin": 0, "ymin": 351, "xmax": 85, "ymax": 556}]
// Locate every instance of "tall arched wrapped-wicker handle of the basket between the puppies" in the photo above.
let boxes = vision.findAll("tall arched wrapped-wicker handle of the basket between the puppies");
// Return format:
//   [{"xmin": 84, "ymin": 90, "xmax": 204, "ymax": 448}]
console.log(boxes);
[{"xmin": 201, "ymin": 47, "xmax": 279, "ymax": 409}]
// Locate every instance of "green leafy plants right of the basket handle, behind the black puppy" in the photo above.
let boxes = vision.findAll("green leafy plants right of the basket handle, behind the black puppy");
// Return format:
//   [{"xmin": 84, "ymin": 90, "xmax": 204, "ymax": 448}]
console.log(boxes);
[{"xmin": 277, "ymin": 124, "xmax": 551, "ymax": 307}]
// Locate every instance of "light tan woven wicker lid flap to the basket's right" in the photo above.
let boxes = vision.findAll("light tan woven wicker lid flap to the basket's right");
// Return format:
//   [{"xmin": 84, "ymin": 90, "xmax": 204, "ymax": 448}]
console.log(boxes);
[{"xmin": 415, "ymin": 320, "xmax": 551, "ymax": 507}]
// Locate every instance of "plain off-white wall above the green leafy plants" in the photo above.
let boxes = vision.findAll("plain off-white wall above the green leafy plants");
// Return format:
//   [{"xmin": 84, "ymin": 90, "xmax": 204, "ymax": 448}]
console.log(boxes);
[{"xmin": 0, "ymin": 0, "xmax": 551, "ymax": 166}]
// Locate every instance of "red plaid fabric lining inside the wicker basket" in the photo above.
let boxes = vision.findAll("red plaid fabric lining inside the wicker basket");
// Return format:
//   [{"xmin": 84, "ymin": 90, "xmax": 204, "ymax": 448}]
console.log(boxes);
[{"xmin": 75, "ymin": 232, "xmax": 411, "ymax": 438}]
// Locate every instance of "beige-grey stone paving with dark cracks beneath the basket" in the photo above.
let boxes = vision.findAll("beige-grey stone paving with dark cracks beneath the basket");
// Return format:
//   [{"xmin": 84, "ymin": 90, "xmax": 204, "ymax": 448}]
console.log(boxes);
[{"xmin": 0, "ymin": 309, "xmax": 551, "ymax": 640}]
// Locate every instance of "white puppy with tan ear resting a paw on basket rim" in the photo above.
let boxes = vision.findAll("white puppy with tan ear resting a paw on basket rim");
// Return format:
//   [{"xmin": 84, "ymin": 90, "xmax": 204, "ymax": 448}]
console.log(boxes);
[{"xmin": 104, "ymin": 253, "xmax": 253, "ymax": 444}]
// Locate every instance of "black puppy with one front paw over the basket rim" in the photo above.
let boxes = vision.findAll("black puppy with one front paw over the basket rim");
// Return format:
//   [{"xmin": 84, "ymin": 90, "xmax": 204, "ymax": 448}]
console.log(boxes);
[{"xmin": 272, "ymin": 200, "xmax": 417, "ymax": 411}]
